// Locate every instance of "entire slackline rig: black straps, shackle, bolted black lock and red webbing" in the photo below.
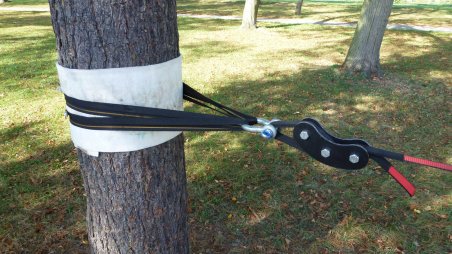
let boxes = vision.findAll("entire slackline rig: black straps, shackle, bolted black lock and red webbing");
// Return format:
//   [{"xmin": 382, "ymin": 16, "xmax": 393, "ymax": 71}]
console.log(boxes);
[{"xmin": 65, "ymin": 83, "xmax": 452, "ymax": 196}]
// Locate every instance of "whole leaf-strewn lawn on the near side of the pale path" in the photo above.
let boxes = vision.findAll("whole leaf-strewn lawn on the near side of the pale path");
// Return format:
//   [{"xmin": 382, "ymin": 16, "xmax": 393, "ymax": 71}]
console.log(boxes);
[{"xmin": 0, "ymin": 9, "xmax": 452, "ymax": 253}]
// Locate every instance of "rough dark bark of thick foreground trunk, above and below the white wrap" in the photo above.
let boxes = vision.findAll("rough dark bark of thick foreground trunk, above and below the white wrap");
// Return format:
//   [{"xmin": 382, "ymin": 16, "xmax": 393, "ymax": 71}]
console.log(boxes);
[{"xmin": 49, "ymin": 0, "xmax": 189, "ymax": 253}]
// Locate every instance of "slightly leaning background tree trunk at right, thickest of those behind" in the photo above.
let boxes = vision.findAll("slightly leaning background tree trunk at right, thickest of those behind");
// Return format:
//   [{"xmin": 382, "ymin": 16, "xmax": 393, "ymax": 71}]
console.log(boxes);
[{"xmin": 343, "ymin": 0, "xmax": 394, "ymax": 78}]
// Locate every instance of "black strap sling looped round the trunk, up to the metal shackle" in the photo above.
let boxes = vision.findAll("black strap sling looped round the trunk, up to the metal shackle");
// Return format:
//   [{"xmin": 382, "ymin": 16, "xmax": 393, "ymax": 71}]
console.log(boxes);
[{"xmin": 65, "ymin": 83, "xmax": 257, "ymax": 131}]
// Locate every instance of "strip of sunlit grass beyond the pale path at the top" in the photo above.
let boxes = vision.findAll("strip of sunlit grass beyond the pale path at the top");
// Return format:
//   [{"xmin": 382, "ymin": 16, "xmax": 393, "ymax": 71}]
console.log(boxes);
[{"xmin": 2, "ymin": 0, "xmax": 452, "ymax": 27}]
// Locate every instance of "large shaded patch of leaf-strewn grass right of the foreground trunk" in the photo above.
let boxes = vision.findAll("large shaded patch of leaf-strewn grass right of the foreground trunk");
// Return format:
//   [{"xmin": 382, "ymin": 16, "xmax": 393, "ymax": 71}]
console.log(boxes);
[{"xmin": 186, "ymin": 65, "xmax": 449, "ymax": 253}]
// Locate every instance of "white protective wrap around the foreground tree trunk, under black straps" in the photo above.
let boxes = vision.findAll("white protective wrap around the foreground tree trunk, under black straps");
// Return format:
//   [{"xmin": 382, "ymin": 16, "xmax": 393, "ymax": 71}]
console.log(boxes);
[{"xmin": 57, "ymin": 57, "xmax": 183, "ymax": 156}]
